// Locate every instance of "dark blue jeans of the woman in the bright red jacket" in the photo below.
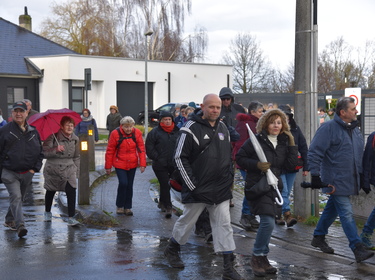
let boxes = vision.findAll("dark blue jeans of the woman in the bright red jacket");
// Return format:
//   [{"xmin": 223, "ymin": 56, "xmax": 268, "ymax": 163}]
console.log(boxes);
[{"xmin": 116, "ymin": 168, "xmax": 137, "ymax": 209}]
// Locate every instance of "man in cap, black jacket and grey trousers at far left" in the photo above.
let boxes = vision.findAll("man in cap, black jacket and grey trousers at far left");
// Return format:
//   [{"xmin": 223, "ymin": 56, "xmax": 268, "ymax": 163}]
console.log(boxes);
[{"xmin": 0, "ymin": 101, "xmax": 43, "ymax": 237}]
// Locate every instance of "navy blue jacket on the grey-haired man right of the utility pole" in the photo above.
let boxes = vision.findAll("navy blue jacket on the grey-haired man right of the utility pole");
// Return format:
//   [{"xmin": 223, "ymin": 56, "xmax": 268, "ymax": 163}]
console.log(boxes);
[{"xmin": 307, "ymin": 114, "xmax": 364, "ymax": 196}]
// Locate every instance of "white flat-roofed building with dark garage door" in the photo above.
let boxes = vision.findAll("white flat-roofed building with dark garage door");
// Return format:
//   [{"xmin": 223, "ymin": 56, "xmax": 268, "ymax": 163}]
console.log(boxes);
[{"xmin": 28, "ymin": 54, "xmax": 232, "ymax": 128}]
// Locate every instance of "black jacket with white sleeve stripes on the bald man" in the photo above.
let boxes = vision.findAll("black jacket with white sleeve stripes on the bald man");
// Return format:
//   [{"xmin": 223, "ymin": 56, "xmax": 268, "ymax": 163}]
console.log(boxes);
[{"xmin": 175, "ymin": 114, "xmax": 233, "ymax": 204}]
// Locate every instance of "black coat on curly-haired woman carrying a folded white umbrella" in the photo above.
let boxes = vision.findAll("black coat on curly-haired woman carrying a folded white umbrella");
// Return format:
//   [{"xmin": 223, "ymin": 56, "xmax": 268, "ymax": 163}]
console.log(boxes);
[{"xmin": 236, "ymin": 131, "xmax": 298, "ymax": 217}]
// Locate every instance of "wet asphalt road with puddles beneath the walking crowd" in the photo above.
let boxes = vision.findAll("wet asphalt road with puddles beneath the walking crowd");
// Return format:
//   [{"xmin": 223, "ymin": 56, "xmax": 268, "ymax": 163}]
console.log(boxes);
[{"xmin": 0, "ymin": 149, "xmax": 375, "ymax": 280}]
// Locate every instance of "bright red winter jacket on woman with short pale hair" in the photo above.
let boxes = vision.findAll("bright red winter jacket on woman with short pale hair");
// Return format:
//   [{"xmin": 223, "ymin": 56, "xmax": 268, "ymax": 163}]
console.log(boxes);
[{"xmin": 105, "ymin": 126, "xmax": 146, "ymax": 170}]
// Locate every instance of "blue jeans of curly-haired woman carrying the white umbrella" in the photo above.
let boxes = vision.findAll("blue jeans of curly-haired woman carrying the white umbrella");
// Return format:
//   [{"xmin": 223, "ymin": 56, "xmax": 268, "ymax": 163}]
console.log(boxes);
[{"xmin": 253, "ymin": 215, "xmax": 275, "ymax": 256}]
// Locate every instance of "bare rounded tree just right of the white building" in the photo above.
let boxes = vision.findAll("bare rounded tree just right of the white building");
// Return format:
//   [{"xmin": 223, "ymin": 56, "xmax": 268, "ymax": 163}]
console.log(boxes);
[{"xmin": 223, "ymin": 33, "xmax": 272, "ymax": 93}]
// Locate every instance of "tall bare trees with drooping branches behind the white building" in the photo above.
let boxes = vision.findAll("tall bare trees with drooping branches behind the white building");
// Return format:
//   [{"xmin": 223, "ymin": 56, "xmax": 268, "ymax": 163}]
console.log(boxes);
[{"xmin": 41, "ymin": 0, "xmax": 207, "ymax": 62}]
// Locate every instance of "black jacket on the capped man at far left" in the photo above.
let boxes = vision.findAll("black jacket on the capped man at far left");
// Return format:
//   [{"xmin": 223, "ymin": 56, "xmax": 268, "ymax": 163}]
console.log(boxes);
[{"xmin": 0, "ymin": 122, "xmax": 43, "ymax": 172}]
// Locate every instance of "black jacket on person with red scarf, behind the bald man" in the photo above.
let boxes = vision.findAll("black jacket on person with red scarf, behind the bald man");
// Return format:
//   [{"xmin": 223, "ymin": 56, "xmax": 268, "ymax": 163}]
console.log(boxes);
[{"xmin": 146, "ymin": 124, "xmax": 179, "ymax": 168}]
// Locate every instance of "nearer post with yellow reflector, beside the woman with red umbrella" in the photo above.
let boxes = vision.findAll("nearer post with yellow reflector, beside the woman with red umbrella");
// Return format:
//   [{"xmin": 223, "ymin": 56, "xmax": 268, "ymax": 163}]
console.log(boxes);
[{"xmin": 78, "ymin": 134, "xmax": 90, "ymax": 205}]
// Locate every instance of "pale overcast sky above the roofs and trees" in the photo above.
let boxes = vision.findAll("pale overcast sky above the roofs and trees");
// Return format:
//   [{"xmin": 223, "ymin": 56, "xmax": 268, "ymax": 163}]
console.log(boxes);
[{"xmin": 0, "ymin": 0, "xmax": 375, "ymax": 69}]
